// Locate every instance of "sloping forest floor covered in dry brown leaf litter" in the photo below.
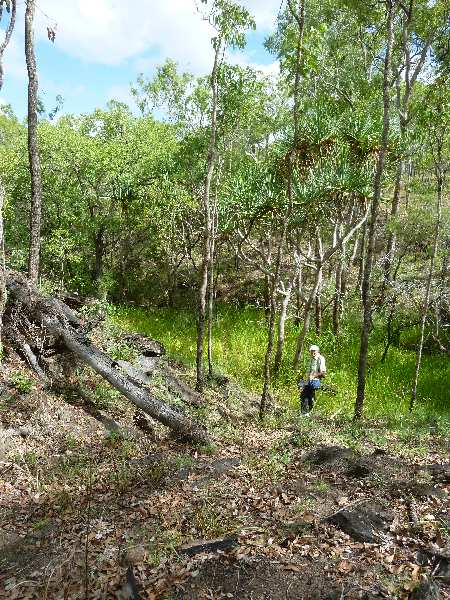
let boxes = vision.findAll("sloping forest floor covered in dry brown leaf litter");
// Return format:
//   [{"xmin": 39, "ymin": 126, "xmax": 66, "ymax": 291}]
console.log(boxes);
[{"xmin": 0, "ymin": 342, "xmax": 450, "ymax": 600}]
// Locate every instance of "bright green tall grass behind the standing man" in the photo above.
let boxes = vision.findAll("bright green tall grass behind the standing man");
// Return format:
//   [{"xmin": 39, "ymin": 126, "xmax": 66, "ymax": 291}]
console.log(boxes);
[{"xmin": 113, "ymin": 306, "xmax": 450, "ymax": 421}]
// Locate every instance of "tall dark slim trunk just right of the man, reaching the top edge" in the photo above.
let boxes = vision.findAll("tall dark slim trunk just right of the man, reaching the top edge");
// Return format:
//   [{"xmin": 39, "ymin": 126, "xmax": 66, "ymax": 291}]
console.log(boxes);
[{"xmin": 354, "ymin": 0, "xmax": 394, "ymax": 419}]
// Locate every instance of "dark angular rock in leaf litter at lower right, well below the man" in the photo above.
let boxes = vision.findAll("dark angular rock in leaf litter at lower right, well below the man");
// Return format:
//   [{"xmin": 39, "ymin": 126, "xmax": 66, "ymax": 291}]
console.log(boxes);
[{"xmin": 326, "ymin": 505, "xmax": 394, "ymax": 543}]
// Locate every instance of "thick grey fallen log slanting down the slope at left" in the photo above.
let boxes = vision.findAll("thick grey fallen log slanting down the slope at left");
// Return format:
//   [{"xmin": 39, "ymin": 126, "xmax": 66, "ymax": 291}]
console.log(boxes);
[{"xmin": 6, "ymin": 270, "xmax": 209, "ymax": 442}]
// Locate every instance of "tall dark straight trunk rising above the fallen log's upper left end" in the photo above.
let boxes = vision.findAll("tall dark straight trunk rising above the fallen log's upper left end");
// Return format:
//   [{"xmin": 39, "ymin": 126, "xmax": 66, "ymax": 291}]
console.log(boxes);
[{"xmin": 25, "ymin": 0, "xmax": 42, "ymax": 283}]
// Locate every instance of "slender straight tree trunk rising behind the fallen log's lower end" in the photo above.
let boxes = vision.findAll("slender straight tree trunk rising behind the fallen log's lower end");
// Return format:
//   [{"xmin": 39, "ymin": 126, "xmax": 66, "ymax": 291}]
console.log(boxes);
[{"xmin": 196, "ymin": 41, "xmax": 221, "ymax": 392}]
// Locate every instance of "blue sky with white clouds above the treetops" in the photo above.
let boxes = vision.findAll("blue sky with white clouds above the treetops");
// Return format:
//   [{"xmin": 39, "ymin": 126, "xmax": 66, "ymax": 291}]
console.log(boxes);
[{"xmin": 0, "ymin": 0, "xmax": 282, "ymax": 118}]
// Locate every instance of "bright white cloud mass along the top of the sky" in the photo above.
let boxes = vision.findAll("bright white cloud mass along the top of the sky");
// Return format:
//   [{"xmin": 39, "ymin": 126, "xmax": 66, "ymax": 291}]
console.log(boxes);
[{"xmin": 37, "ymin": 0, "xmax": 280, "ymax": 73}]
